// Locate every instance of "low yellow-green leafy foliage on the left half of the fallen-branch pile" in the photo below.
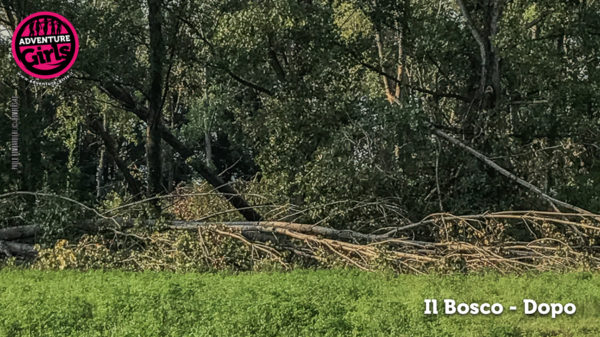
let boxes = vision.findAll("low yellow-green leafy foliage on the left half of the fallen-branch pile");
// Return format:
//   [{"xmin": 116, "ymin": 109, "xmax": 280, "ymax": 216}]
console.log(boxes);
[{"xmin": 32, "ymin": 228, "xmax": 281, "ymax": 272}]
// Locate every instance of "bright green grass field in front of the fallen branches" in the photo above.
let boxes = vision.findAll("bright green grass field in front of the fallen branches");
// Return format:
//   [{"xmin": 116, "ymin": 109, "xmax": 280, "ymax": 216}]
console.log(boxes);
[{"xmin": 0, "ymin": 269, "xmax": 600, "ymax": 337}]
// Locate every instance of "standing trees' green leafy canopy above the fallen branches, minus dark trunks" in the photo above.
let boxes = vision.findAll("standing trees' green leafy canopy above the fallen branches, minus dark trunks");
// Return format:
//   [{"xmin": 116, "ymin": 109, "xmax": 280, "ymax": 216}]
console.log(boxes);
[{"xmin": 0, "ymin": 0, "xmax": 600, "ymax": 234}]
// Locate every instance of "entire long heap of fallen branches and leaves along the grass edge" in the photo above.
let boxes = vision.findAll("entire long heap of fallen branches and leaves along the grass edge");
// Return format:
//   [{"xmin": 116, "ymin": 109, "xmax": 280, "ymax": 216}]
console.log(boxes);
[{"xmin": 0, "ymin": 190, "xmax": 600, "ymax": 273}]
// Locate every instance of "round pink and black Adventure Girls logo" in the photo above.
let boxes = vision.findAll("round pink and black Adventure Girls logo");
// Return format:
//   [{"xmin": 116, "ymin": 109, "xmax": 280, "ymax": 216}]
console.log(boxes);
[{"xmin": 12, "ymin": 12, "xmax": 79, "ymax": 79}]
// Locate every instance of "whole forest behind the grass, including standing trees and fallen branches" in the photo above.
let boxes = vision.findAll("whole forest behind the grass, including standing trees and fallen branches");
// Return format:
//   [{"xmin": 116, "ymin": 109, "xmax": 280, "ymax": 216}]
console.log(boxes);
[{"xmin": 0, "ymin": 0, "xmax": 600, "ymax": 273}]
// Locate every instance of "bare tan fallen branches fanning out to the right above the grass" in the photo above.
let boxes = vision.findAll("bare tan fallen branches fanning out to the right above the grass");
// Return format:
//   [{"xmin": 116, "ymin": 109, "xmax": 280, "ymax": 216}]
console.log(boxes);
[{"xmin": 162, "ymin": 211, "xmax": 600, "ymax": 273}]
